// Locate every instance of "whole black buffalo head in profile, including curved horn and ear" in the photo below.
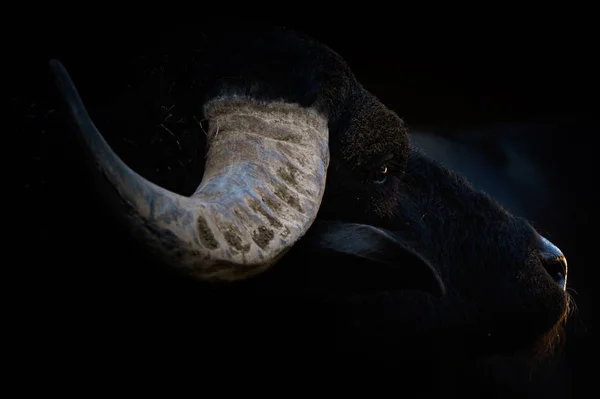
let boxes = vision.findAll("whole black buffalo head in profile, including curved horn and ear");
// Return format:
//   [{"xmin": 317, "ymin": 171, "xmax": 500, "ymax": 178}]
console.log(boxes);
[{"xmin": 51, "ymin": 30, "xmax": 568, "ymax": 366}]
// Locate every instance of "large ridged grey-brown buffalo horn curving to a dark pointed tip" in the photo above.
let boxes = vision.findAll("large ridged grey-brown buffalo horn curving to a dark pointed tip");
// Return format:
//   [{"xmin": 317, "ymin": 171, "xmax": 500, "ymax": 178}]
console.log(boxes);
[{"xmin": 50, "ymin": 60, "xmax": 329, "ymax": 281}]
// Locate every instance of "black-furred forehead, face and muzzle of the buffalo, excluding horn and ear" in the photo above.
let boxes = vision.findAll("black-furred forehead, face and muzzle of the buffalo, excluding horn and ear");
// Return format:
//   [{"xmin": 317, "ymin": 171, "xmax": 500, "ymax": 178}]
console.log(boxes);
[{"xmin": 184, "ymin": 31, "xmax": 566, "ymax": 352}]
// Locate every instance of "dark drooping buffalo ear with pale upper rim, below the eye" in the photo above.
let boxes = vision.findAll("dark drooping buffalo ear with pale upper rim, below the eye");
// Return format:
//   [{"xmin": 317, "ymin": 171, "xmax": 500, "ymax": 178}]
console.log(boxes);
[{"xmin": 301, "ymin": 220, "xmax": 445, "ymax": 297}]
